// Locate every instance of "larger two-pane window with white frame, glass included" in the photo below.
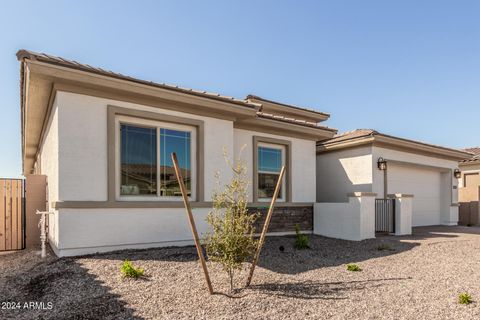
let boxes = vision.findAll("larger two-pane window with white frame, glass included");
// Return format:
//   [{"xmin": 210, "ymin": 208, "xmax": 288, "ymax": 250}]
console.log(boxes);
[{"xmin": 115, "ymin": 116, "xmax": 196, "ymax": 201}]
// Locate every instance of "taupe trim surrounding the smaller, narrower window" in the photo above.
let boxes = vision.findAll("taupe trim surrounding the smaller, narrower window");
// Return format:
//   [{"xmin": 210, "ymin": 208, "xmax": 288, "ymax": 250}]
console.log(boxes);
[{"xmin": 252, "ymin": 136, "xmax": 292, "ymax": 202}]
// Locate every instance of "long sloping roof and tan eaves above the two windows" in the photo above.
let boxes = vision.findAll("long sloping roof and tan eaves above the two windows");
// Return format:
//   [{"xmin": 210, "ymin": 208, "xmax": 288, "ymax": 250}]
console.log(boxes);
[{"xmin": 17, "ymin": 50, "xmax": 336, "ymax": 174}]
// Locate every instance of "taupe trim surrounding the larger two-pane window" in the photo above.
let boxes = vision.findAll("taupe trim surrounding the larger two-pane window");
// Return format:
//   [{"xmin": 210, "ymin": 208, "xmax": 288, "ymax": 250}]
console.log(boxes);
[{"xmin": 107, "ymin": 105, "xmax": 204, "ymax": 203}]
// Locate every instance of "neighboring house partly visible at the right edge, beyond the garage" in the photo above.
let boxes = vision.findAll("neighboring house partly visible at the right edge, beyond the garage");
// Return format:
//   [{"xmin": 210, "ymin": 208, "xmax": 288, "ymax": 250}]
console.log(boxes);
[{"xmin": 458, "ymin": 147, "xmax": 480, "ymax": 225}]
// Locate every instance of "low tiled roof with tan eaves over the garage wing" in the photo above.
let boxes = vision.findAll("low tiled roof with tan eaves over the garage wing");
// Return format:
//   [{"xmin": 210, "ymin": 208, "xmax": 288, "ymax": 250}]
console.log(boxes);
[{"xmin": 317, "ymin": 129, "xmax": 472, "ymax": 161}]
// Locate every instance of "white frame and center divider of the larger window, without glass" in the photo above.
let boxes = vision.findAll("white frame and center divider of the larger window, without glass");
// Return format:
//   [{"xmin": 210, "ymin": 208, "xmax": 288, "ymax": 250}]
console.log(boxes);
[{"xmin": 115, "ymin": 115, "xmax": 197, "ymax": 201}]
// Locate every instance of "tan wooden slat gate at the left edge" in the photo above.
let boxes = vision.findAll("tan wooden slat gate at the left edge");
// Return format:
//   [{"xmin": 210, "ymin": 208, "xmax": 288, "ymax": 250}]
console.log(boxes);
[{"xmin": 0, "ymin": 178, "xmax": 25, "ymax": 251}]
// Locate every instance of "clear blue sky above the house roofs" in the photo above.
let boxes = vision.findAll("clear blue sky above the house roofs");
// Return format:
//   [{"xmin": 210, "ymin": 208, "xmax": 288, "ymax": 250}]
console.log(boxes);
[{"xmin": 0, "ymin": 0, "xmax": 480, "ymax": 177}]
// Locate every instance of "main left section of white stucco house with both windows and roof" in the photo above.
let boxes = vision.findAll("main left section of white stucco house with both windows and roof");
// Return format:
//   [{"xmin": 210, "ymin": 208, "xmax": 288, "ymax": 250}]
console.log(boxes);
[{"xmin": 17, "ymin": 50, "xmax": 336, "ymax": 256}]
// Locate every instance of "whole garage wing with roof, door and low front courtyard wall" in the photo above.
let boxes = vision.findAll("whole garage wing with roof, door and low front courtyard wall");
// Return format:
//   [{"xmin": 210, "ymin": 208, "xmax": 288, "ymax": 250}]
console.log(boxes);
[{"xmin": 315, "ymin": 129, "xmax": 471, "ymax": 240}]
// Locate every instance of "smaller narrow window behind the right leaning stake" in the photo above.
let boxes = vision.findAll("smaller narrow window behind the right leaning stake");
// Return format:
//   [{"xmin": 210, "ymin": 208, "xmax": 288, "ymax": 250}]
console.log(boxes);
[{"xmin": 257, "ymin": 144, "xmax": 285, "ymax": 200}]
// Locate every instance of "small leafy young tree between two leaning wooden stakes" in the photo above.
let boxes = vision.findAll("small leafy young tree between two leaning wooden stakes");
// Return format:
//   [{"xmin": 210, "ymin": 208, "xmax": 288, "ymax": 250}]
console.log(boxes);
[{"xmin": 204, "ymin": 151, "xmax": 258, "ymax": 291}]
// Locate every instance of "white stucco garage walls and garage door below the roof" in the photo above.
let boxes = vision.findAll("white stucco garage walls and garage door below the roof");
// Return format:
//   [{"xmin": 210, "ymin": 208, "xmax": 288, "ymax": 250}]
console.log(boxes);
[{"xmin": 317, "ymin": 142, "xmax": 464, "ymax": 226}]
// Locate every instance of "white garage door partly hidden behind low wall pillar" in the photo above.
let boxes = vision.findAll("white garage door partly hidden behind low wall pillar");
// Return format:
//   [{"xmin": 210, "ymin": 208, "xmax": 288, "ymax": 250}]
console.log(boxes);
[{"xmin": 388, "ymin": 164, "xmax": 442, "ymax": 227}]
